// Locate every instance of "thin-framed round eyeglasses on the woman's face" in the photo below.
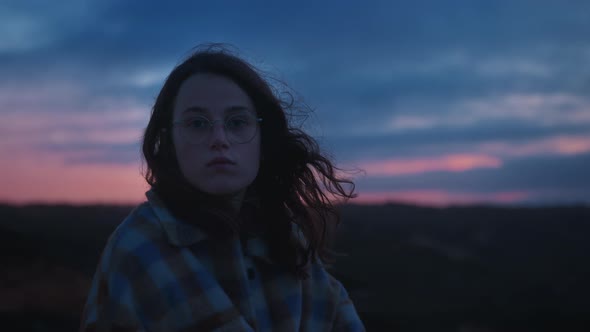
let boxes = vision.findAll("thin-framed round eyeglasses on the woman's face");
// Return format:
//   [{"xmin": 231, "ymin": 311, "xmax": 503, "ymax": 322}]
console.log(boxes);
[{"xmin": 172, "ymin": 114, "xmax": 262, "ymax": 144}]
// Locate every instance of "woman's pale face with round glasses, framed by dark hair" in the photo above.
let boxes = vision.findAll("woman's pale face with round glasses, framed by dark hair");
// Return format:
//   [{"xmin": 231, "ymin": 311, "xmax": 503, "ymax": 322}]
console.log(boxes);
[{"xmin": 172, "ymin": 74, "xmax": 260, "ymax": 197}]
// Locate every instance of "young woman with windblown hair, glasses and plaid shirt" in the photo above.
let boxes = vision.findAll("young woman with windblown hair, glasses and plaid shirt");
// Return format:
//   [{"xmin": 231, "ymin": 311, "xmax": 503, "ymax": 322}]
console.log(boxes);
[{"xmin": 81, "ymin": 47, "xmax": 364, "ymax": 331}]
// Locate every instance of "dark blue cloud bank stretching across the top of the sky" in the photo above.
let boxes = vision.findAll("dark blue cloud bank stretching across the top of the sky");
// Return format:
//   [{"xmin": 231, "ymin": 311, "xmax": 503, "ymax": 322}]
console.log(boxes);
[{"xmin": 0, "ymin": 1, "xmax": 590, "ymax": 115}]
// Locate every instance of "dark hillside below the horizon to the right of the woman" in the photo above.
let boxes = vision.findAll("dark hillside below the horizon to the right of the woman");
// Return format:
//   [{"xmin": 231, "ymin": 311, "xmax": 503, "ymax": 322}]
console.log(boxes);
[{"xmin": 335, "ymin": 204, "xmax": 590, "ymax": 331}]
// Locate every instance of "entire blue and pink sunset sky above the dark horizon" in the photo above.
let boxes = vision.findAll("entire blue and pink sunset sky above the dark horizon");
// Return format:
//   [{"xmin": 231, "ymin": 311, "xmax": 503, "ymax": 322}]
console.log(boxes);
[{"xmin": 0, "ymin": 0, "xmax": 590, "ymax": 206}]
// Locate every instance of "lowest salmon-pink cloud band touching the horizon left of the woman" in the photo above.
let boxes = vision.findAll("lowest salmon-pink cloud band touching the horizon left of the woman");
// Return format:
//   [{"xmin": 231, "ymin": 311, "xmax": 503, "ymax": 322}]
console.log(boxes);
[{"xmin": 0, "ymin": 156, "xmax": 147, "ymax": 204}]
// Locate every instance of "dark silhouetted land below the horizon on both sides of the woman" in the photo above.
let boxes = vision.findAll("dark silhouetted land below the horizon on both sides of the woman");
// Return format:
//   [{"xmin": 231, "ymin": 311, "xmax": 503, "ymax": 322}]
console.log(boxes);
[{"xmin": 0, "ymin": 204, "xmax": 590, "ymax": 332}]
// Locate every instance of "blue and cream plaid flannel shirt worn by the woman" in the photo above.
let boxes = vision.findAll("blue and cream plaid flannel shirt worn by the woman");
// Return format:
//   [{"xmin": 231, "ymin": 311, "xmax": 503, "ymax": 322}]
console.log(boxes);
[{"xmin": 80, "ymin": 191, "xmax": 364, "ymax": 331}]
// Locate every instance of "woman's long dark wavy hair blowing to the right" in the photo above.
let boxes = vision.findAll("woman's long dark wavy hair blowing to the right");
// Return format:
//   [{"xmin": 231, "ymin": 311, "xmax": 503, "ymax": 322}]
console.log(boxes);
[{"xmin": 142, "ymin": 44, "xmax": 356, "ymax": 278}]
